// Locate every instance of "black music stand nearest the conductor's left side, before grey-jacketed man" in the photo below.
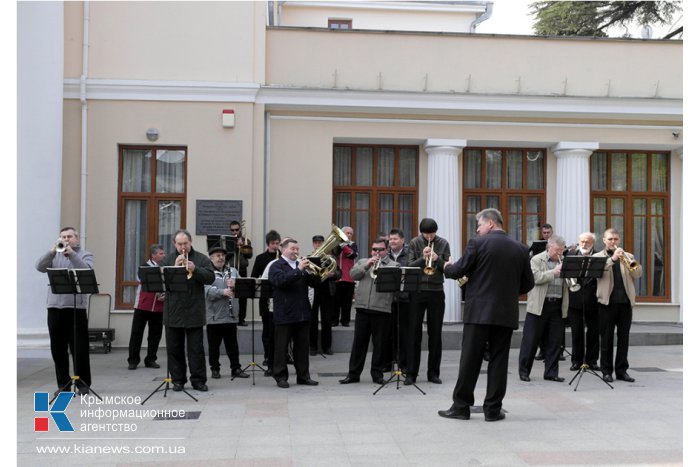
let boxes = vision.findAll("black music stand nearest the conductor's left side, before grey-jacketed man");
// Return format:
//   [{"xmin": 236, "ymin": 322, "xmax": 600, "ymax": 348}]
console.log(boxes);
[{"xmin": 372, "ymin": 267, "xmax": 425, "ymax": 395}]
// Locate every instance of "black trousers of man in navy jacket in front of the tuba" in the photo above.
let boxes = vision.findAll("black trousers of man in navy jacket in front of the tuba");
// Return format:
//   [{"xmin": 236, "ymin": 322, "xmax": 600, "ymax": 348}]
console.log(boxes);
[{"xmin": 272, "ymin": 321, "xmax": 311, "ymax": 383}]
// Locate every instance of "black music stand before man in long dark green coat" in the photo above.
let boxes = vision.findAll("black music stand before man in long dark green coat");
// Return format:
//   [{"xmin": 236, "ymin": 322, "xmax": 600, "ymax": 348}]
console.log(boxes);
[{"xmin": 138, "ymin": 266, "xmax": 199, "ymax": 405}]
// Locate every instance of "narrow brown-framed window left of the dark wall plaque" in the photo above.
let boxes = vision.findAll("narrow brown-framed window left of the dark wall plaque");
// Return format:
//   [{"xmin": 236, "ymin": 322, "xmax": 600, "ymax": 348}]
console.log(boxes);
[{"xmin": 115, "ymin": 146, "xmax": 187, "ymax": 308}]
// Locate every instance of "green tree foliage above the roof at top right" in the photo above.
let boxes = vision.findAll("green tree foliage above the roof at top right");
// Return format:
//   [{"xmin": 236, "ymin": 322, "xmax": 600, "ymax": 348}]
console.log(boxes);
[{"xmin": 530, "ymin": 0, "xmax": 682, "ymax": 37}]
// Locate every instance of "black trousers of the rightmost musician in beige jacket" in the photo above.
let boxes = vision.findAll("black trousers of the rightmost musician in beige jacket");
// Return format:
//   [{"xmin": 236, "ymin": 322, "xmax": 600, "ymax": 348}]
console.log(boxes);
[{"xmin": 598, "ymin": 303, "xmax": 632, "ymax": 376}]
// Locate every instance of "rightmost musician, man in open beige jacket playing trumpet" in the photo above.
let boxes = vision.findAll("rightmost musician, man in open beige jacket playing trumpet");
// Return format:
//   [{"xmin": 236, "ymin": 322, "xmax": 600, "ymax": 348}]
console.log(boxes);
[{"xmin": 595, "ymin": 228, "xmax": 642, "ymax": 383}]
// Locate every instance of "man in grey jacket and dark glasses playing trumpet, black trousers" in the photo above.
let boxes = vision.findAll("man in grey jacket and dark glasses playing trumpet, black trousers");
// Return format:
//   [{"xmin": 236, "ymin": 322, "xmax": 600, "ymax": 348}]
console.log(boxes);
[{"xmin": 339, "ymin": 238, "xmax": 400, "ymax": 384}]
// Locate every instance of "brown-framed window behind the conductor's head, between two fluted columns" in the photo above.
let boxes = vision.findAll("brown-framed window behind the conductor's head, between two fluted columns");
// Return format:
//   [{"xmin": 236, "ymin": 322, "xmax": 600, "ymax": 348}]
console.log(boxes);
[{"xmin": 463, "ymin": 148, "xmax": 547, "ymax": 245}]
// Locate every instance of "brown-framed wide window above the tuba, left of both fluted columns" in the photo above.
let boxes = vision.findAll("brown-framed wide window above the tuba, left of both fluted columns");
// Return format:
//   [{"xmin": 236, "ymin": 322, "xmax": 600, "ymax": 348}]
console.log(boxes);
[{"xmin": 333, "ymin": 144, "xmax": 418, "ymax": 256}]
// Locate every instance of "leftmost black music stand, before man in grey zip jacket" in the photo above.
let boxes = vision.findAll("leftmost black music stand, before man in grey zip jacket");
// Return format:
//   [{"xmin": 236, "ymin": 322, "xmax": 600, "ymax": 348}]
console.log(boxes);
[{"xmin": 46, "ymin": 268, "xmax": 102, "ymax": 403}]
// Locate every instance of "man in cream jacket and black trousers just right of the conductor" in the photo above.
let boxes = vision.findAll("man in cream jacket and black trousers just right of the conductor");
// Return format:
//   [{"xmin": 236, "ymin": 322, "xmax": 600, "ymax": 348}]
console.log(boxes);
[{"xmin": 518, "ymin": 235, "xmax": 569, "ymax": 382}]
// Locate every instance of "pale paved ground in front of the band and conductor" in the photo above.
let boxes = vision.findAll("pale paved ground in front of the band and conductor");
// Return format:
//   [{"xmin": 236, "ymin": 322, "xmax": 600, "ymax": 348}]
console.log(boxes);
[{"xmin": 17, "ymin": 338, "xmax": 683, "ymax": 467}]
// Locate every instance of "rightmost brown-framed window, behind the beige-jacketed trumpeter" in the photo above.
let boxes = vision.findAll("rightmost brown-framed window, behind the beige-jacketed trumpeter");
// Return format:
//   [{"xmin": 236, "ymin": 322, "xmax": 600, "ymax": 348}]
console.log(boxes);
[{"xmin": 591, "ymin": 151, "xmax": 670, "ymax": 302}]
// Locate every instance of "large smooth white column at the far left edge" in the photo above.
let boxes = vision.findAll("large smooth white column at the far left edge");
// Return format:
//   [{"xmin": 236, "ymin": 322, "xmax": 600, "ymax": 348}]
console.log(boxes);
[{"xmin": 17, "ymin": 2, "xmax": 63, "ymax": 356}]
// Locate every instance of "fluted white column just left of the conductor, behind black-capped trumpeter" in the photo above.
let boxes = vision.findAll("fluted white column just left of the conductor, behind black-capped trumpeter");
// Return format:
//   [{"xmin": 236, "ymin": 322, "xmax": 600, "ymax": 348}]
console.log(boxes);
[{"xmin": 424, "ymin": 139, "xmax": 467, "ymax": 323}]
